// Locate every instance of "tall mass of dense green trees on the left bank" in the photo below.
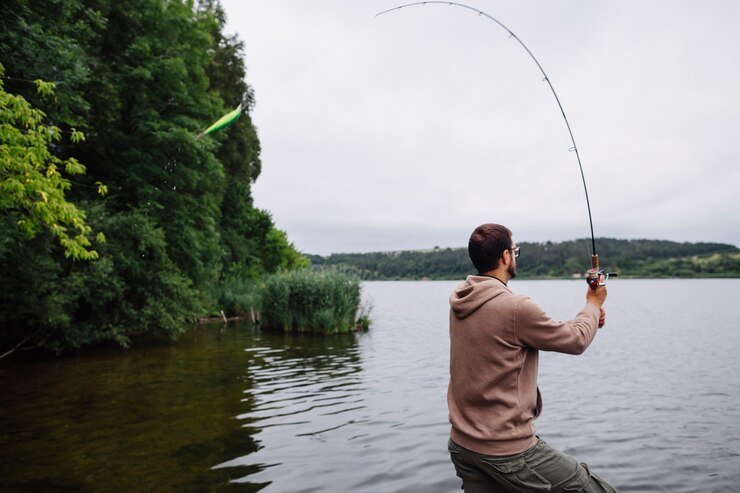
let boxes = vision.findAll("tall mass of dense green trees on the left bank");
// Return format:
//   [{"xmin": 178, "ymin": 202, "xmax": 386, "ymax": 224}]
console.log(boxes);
[{"xmin": 0, "ymin": 0, "xmax": 307, "ymax": 351}]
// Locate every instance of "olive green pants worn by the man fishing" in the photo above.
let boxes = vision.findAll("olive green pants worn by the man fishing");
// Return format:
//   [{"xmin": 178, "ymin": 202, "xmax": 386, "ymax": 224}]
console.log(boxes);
[{"xmin": 448, "ymin": 440, "xmax": 617, "ymax": 493}]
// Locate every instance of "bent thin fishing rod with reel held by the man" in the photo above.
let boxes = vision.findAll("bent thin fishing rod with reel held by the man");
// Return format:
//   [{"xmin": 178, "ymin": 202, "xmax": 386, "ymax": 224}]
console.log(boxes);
[{"xmin": 375, "ymin": 0, "xmax": 617, "ymax": 289}]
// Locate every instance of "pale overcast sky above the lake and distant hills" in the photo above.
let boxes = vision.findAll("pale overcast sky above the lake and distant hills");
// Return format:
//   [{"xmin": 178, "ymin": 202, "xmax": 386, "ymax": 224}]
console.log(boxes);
[{"xmin": 222, "ymin": 0, "xmax": 740, "ymax": 254}]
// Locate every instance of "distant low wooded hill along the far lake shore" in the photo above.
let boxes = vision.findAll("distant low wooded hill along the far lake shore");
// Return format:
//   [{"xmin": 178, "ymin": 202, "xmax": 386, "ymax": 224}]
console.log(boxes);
[{"xmin": 308, "ymin": 238, "xmax": 740, "ymax": 280}]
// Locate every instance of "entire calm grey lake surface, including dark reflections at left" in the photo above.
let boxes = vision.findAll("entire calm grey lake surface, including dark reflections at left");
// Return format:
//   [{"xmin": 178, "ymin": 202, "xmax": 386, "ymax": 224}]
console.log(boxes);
[{"xmin": 0, "ymin": 279, "xmax": 740, "ymax": 493}]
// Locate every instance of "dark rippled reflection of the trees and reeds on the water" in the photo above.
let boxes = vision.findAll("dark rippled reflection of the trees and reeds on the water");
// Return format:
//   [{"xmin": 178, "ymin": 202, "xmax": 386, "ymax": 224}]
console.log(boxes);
[{"xmin": 0, "ymin": 324, "xmax": 360, "ymax": 492}]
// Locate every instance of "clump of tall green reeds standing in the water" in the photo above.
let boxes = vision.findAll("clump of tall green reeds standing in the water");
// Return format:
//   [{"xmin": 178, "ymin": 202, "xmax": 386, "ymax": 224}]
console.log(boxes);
[{"xmin": 260, "ymin": 269, "xmax": 370, "ymax": 334}]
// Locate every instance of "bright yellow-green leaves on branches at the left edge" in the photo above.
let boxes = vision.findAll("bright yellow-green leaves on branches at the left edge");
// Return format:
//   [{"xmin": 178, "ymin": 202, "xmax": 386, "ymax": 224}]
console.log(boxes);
[{"xmin": 0, "ymin": 64, "xmax": 105, "ymax": 260}]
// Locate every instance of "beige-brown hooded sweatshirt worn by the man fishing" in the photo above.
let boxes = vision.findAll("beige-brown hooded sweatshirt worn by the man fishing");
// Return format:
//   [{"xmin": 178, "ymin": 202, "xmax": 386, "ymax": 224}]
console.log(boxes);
[{"xmin": 447, "ymin": 276, "xmax": 600, "ymax": 455}]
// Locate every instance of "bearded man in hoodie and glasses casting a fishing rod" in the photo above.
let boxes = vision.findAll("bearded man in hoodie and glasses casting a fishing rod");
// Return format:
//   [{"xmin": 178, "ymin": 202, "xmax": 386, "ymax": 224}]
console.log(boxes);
[{"xmin": 447, "ymin": 224, "xmax": 617, "ymax": 493}]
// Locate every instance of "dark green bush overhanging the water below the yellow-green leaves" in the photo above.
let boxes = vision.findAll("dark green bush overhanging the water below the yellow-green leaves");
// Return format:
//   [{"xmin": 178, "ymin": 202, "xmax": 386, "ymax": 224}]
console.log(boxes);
[{"xmin": 0, "ymin": 207, "xmax": 205, "ymax": 352}]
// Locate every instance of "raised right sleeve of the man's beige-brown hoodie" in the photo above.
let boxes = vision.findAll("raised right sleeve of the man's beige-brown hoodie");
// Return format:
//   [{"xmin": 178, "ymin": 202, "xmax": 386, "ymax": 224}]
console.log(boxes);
[{"xmin": 514, "ymin": 297, "xmax": 600, "ymax": 354}]
